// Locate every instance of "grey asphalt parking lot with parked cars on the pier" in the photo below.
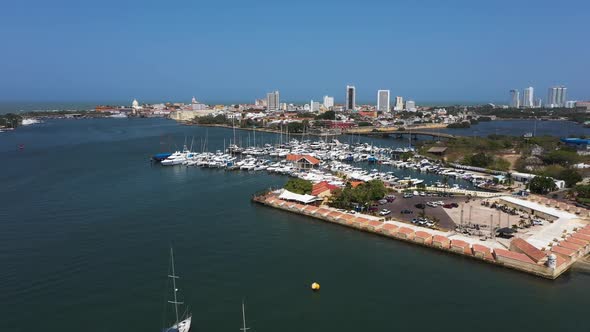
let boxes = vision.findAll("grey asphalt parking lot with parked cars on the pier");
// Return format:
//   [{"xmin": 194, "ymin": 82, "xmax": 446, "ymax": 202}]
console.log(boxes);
[{"xmin": 378, "ymin": 194, "xmax": 466, "ymax": 230}]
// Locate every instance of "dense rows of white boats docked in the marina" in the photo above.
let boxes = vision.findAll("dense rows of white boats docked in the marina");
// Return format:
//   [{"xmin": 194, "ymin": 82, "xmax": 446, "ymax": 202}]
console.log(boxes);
[{"xmin": 153, "ymin": 140, "xmax": 489, "ymax": 187}]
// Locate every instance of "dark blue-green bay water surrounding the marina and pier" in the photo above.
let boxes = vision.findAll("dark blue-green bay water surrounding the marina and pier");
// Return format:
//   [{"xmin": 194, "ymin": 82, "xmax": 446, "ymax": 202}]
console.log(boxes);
[{"xmin": 0, "ymin": 119, "xmax": 590, "ymax": 332}]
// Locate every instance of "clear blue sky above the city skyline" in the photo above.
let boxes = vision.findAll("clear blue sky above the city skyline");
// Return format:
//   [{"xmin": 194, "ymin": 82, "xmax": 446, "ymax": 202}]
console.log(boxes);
[{"xmin": 0, "ymin": 0, "xmax": 590, "ymax": 103}]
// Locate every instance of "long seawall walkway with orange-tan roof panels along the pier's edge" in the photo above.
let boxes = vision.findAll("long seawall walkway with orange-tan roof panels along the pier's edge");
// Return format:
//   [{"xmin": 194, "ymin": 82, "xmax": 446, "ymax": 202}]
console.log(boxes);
[{"xmin": 253, "ymin": 193, "xmax": 590, "ymax": 279}]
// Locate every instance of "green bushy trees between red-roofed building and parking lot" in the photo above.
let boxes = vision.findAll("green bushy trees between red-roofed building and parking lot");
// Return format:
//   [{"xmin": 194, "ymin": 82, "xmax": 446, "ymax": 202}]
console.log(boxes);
[{"xmin": 330, "ymin": 180, "xmax": 387, "ymax": 209}]
